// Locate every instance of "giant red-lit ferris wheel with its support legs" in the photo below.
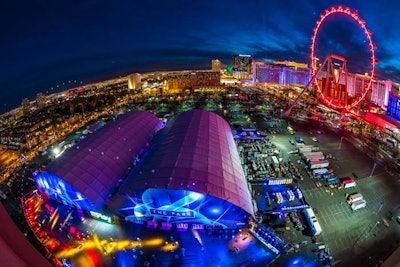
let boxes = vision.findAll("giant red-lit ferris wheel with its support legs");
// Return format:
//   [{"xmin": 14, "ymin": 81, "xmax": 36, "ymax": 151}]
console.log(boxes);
[{"xmin": 310, "ymin": 6, "xmax": 377, "ymax": 110}]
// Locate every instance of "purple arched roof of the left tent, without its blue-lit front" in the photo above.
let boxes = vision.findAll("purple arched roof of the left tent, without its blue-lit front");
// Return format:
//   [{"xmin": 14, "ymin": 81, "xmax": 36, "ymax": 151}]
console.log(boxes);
[{"xmin": 46, "ymin": 111, "xmax": 162, "ymax": 208}]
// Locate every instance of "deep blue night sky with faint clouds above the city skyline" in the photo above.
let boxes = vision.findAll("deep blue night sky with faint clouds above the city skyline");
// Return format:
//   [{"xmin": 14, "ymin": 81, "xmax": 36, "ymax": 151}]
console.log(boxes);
[{"xmin": 0, "ymin": 0, "xmax": 400, "ymax": 112}]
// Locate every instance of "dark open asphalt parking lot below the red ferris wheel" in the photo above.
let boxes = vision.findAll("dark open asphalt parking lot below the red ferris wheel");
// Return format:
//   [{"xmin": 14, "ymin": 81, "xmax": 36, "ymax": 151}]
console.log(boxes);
[{"xmin": 282, "ymin": 121, "xmax": 400, "ymax": 266}]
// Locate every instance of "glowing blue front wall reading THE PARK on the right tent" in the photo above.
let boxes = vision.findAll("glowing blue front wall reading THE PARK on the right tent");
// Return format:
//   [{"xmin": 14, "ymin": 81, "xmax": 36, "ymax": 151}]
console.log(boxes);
[{"xmin": 114, "ymin": 188, "xmax": 249, "ymax": 228}]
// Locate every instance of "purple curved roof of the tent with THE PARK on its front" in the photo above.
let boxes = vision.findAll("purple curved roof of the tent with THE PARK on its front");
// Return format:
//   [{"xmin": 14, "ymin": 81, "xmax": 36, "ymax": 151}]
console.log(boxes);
[{"xmin": 119, "ymin": 110, "xmax": 254, "ymax": 215}]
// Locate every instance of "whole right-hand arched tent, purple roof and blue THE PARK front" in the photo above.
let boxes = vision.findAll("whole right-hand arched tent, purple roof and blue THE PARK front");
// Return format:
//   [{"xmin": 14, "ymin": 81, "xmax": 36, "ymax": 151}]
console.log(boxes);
[{"xmin": 110, "ymin": 110, "xmax": 254, "ymax": 228}]
